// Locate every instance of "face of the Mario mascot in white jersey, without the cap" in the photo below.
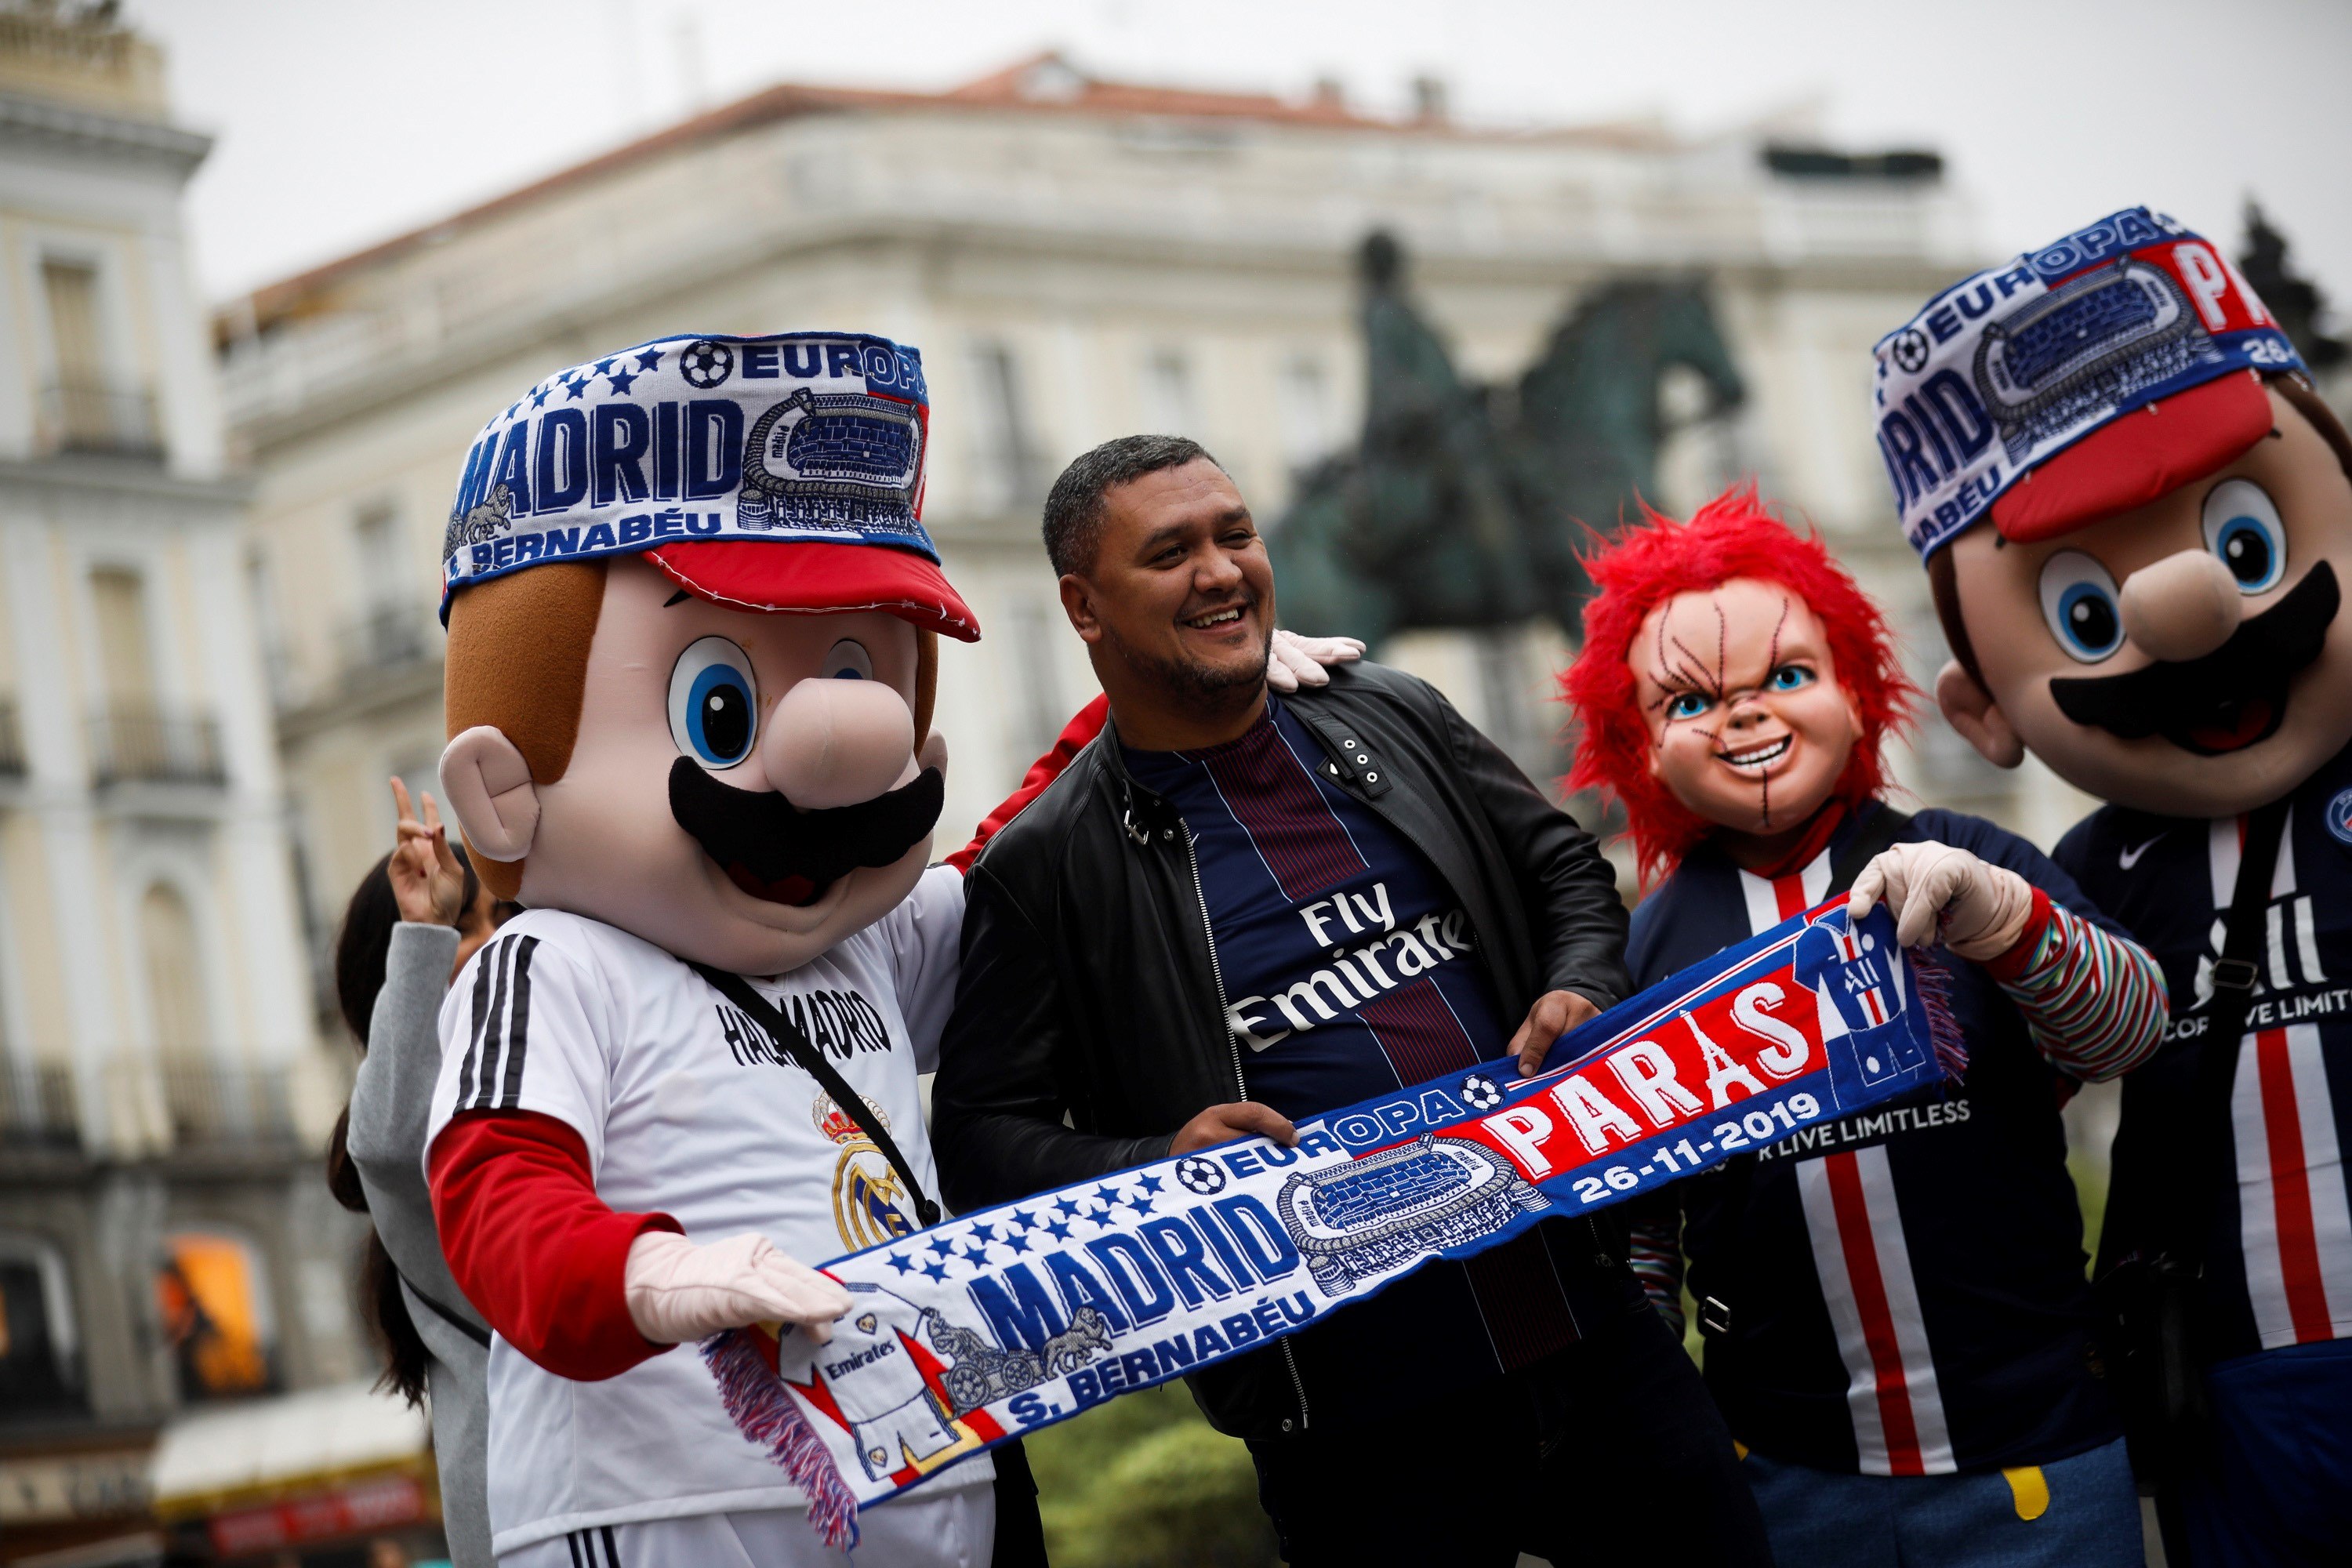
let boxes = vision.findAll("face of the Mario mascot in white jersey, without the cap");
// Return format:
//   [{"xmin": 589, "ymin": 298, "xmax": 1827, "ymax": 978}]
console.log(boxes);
[{"xmin": 522, "ymin": 557, "xmax": 936, "ymax": 975}]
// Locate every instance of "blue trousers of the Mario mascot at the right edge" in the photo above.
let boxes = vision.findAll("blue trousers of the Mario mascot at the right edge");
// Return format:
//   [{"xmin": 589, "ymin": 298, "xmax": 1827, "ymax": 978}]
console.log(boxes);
[{"xmin": 2173, "ymin": 1340, "xmax": 2352, "ymax": 1568}]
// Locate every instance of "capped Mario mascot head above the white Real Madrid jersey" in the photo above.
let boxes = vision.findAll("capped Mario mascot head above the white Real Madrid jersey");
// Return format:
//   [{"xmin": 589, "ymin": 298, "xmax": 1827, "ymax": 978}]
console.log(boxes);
[{"xmin": 442, "ymin": 334, "xmax": 978, "ymax": 973}]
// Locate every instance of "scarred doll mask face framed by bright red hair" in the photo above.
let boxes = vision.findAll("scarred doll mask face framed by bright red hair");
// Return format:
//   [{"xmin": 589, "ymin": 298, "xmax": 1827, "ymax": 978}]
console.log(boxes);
[{"xmin": 1625, "ymin": 579, "xmax": 1863, "ymax": 834}]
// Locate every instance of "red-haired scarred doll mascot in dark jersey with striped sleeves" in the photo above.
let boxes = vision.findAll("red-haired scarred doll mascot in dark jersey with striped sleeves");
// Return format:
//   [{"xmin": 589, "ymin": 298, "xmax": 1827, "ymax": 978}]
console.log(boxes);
[{"xmin": 1564, "ymin": 492, "xmax": 2164, "ymax": 1568}]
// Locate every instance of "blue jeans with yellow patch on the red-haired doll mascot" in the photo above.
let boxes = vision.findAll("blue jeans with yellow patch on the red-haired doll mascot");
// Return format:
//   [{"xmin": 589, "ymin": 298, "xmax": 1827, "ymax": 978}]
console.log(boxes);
[{"xmin": 1740, "ymin": 1439, "xmax": 2145, "ymax": 1568}]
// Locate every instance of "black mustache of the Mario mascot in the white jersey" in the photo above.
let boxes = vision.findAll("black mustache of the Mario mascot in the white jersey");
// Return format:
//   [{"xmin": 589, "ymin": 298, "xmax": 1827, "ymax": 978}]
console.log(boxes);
[{"xmin": 670, "ymin": 757, "xmax": 948, "ymax": 905}]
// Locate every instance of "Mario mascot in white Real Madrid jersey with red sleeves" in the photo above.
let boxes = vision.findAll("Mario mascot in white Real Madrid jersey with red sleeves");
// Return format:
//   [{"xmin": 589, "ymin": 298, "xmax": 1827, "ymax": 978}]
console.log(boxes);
[{"xmin": 428, "ymin": 334, "xmax": 995, "ymax": 1568}]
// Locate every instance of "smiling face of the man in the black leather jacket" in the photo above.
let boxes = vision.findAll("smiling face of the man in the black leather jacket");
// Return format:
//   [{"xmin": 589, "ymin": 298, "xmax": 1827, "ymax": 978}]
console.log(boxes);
[{"xmin": 1063, "ymin": 459, "xmax": 1275, "ymax": 708}]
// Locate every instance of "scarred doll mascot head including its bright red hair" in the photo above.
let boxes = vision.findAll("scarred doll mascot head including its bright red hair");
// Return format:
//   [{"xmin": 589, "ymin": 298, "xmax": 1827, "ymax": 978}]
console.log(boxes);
[{"xmin": 1562, "ymin": 489, "xmax": 1917, "ymax": 881}]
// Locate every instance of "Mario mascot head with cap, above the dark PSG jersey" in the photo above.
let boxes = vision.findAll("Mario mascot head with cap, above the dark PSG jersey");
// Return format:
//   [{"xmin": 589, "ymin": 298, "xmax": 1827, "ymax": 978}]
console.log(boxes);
[{"xmin": 1875, "ymin": 207, "xmax": 2352, "ymax": 815}]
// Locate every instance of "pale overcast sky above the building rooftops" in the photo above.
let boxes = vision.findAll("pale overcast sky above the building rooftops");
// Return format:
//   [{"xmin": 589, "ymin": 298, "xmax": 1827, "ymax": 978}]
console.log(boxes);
[{"xmin": 127, "ymin": 0, "xmax": 2352, "ymax": 327}]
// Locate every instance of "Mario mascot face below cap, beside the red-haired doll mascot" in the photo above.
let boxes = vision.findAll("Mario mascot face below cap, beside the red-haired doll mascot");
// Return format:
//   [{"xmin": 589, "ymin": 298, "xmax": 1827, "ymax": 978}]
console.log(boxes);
[{"xmin": 1938, "ymin": 393, "xmax": 2352, "ymax": 815}]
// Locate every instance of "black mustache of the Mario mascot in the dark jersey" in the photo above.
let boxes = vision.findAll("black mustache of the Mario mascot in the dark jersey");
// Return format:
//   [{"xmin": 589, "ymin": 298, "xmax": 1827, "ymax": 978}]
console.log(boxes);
[{"xmin": 2051, "ymin": 562, "xmax": 2340, "ymax": 757}]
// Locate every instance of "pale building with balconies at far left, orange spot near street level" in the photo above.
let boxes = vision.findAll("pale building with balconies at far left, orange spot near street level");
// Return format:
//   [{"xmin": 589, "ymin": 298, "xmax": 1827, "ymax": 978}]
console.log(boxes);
[{"xmin": 0, "ymin": 5, "xmax": 360, "ymax": 1559}]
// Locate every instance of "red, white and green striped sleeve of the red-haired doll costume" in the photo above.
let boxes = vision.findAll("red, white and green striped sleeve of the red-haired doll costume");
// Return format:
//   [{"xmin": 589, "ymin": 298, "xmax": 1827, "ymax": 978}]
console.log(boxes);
[{"xmin": 1985, "ymin": 888, "xmax": 2171, "ymax": 1083}]
